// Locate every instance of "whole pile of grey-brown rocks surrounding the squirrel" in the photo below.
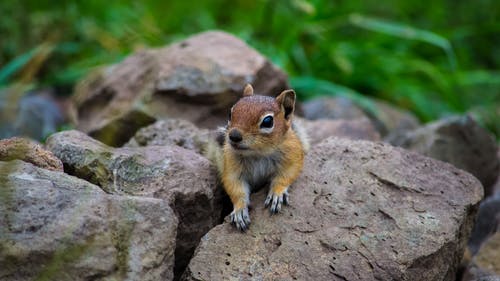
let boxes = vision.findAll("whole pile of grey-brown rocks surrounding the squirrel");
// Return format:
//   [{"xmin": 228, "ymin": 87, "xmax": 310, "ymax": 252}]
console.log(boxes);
[{"xmin": 0, "ymin": 31, "xmax": 500, "ymax": 280}]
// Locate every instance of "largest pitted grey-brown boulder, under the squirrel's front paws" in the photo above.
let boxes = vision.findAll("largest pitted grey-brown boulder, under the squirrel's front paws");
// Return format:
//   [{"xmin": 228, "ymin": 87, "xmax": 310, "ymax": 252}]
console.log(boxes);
[{"xmin": 183, "ymin": 138, "xmax": 483, "ymax": 281}]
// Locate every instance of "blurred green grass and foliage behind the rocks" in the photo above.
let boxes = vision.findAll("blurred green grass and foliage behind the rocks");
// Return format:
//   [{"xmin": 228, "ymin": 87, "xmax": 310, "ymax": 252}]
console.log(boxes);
[{"xmin": 0, "ymin": 0, "xmax": 500, "ymax": 137}]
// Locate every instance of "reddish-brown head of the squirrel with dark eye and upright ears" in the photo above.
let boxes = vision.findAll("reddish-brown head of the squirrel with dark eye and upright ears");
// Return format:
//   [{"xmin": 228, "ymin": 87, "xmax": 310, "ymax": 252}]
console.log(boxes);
[{"xmin": 226, "ymin": 84, "xmax": 295, "ymax": 154}]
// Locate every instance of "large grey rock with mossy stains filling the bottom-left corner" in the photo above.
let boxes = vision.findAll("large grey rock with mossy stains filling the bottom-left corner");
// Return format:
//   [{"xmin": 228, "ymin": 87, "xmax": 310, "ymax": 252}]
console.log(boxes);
[{"xmin": 0, "ymin": 160, "xmax": 177, "ymax": 281}]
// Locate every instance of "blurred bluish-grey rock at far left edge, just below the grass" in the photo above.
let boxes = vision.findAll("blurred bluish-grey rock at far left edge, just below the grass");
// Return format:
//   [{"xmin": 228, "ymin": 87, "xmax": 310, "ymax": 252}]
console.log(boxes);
[{"xmin": 0, "ymin": 88, "xmax": 65, "ymax": 141}]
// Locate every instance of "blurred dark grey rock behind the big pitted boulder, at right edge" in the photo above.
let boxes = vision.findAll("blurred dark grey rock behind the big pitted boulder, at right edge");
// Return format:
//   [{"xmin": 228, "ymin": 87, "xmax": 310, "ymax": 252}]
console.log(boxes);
[{"xmin": 390, "ymin": 116, "xmax": 500, "ymax": 196}]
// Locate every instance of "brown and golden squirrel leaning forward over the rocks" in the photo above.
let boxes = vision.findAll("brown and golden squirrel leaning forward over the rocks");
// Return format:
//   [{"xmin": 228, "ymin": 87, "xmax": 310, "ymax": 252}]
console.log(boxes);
[{"xmin": 207, "ymin": 84, "xmax": 309, "ymax": 231}]
